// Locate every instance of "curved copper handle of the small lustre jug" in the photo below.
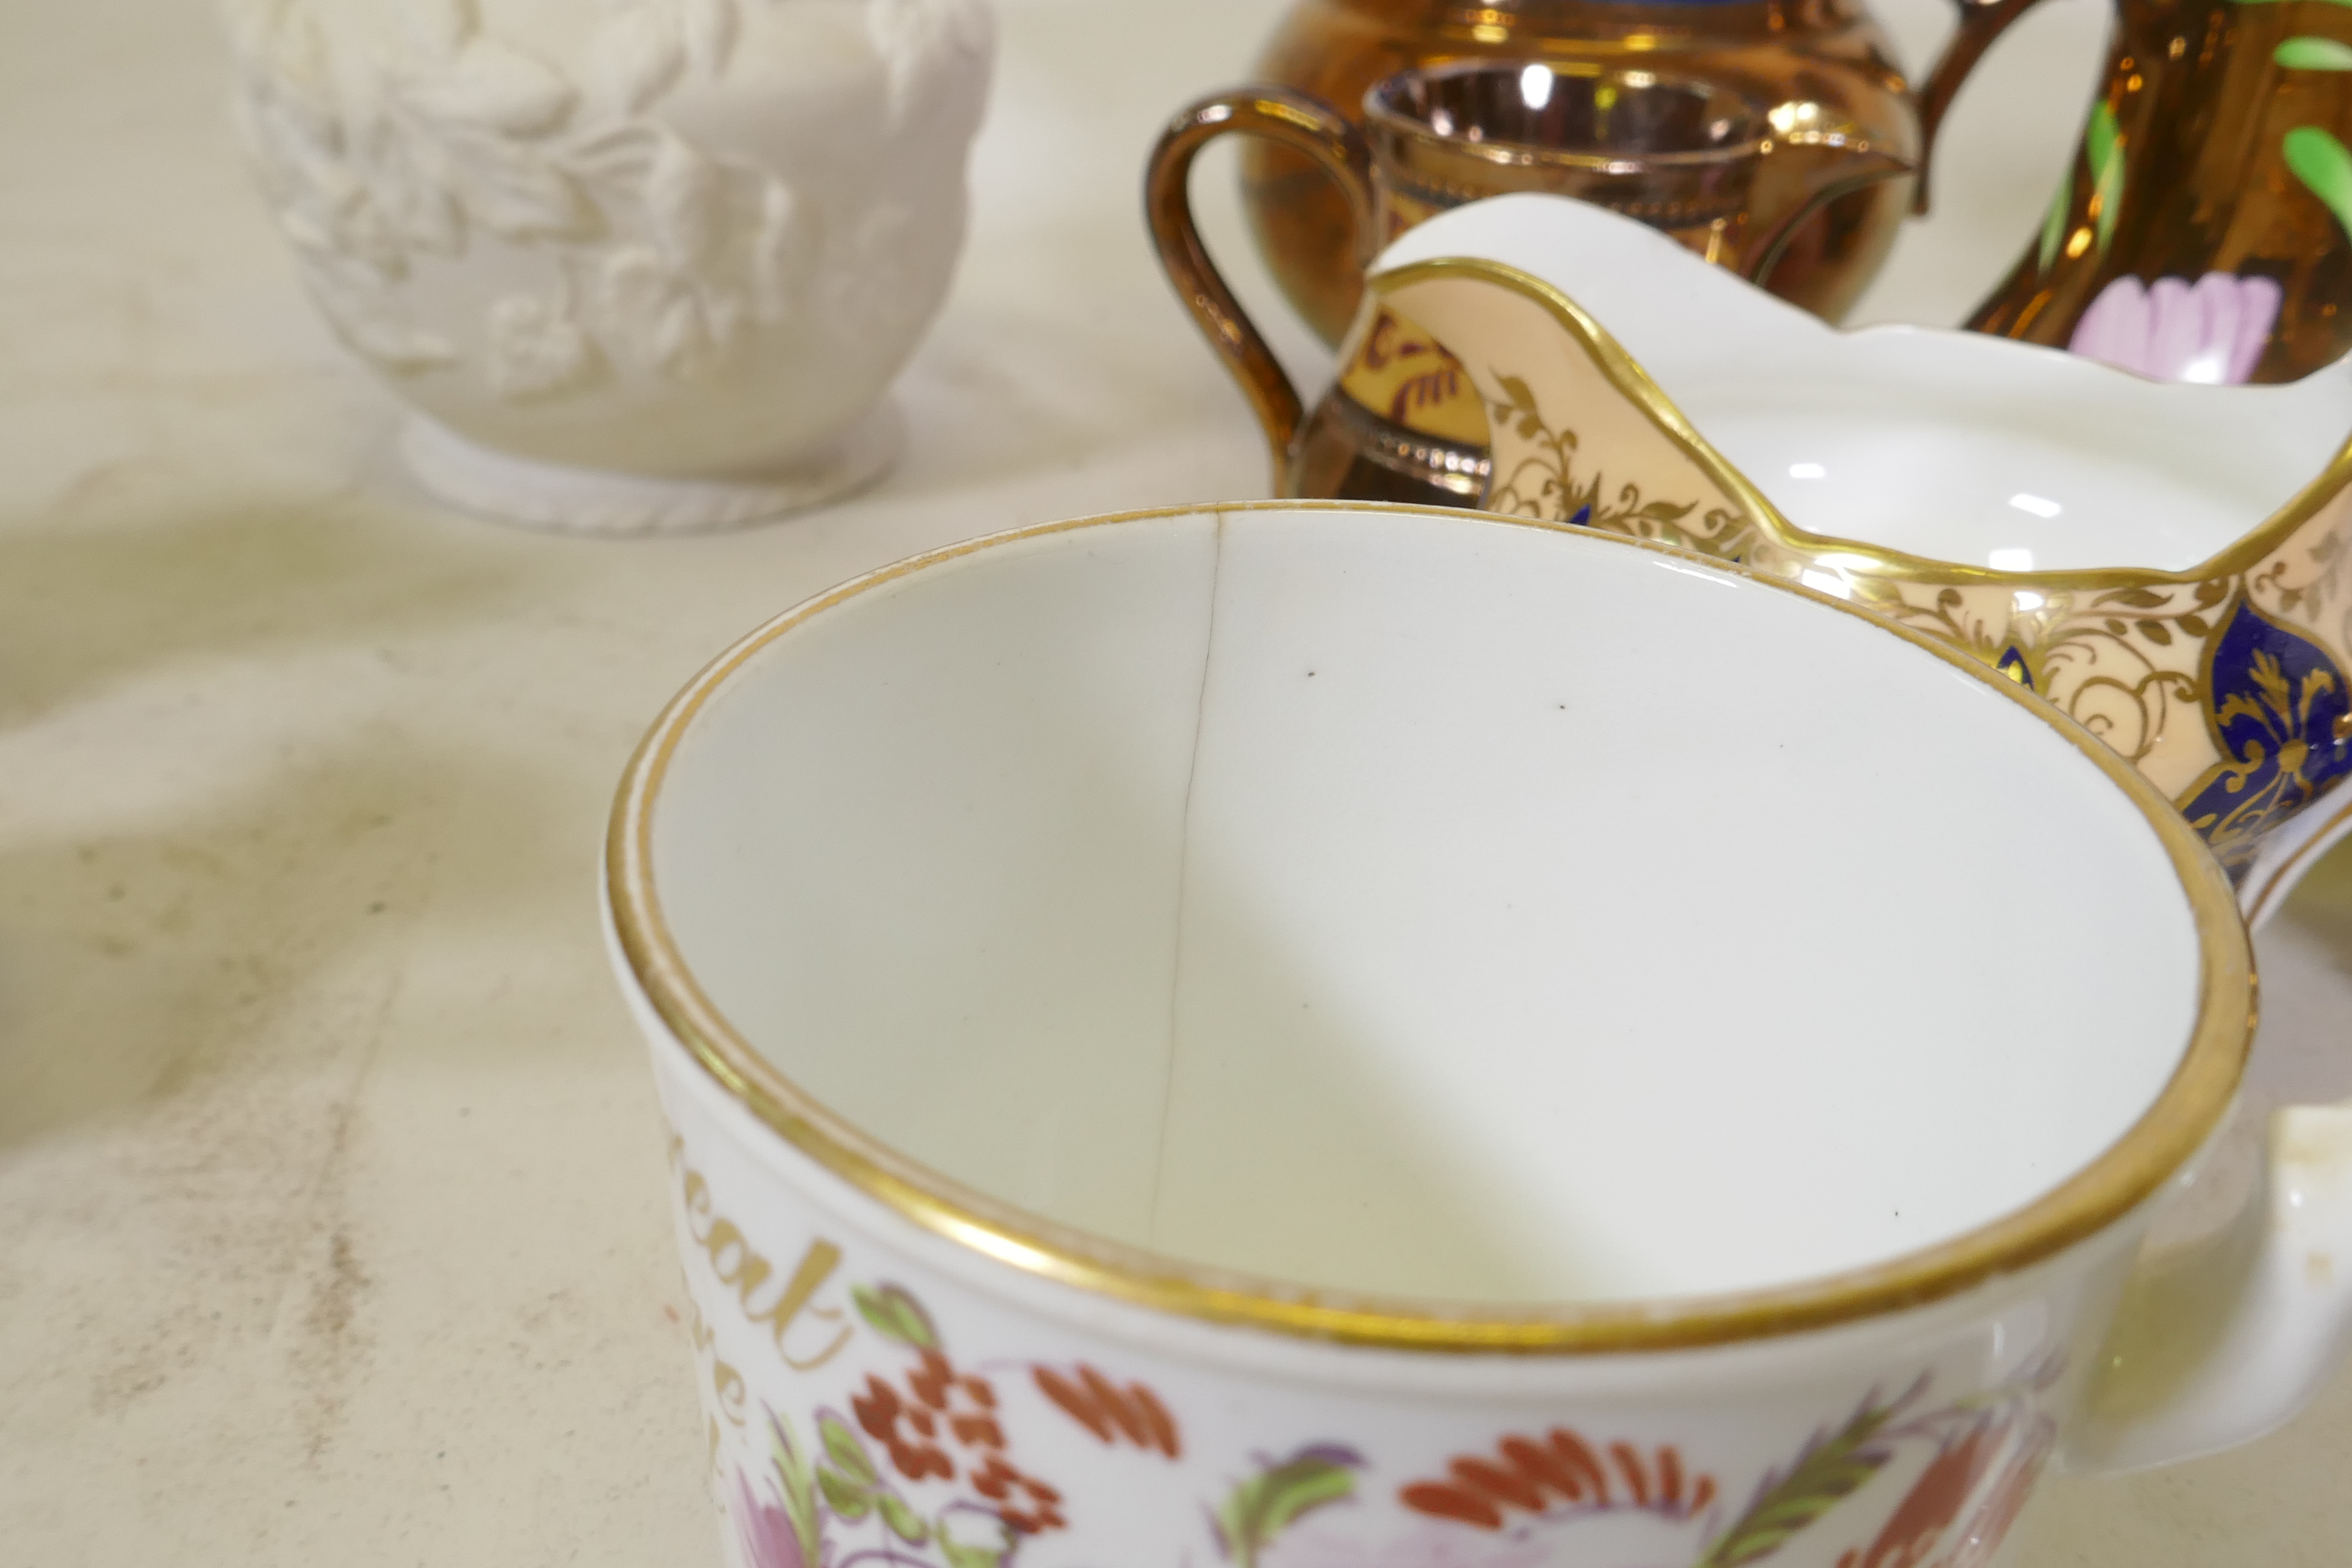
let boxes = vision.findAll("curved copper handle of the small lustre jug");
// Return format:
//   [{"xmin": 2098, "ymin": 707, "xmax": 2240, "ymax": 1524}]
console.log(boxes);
[{"xmin": 1143, "ymin": 87, "xmax": 1378, "ymax": 489}]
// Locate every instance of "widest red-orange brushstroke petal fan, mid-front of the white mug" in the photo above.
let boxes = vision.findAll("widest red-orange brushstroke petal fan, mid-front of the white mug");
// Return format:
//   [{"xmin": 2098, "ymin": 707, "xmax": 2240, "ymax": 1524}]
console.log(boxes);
[{"xmin": 1399, "ymin": 1427, "xmax": 1717, "ymax": 1530}]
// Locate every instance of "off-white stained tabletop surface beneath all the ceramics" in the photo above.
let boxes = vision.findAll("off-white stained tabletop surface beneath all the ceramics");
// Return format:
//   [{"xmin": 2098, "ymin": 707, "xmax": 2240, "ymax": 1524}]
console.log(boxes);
[{"xmin": 0, "ymin": 0, "xmax": 2352, "ymax": 1568}]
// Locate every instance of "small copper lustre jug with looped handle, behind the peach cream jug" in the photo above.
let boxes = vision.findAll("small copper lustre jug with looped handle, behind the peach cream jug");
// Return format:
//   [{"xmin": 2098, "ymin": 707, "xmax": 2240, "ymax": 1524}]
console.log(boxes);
[{"xmin": 1145, "ymin": 61, "xmax": 1912, "ymax": 506}]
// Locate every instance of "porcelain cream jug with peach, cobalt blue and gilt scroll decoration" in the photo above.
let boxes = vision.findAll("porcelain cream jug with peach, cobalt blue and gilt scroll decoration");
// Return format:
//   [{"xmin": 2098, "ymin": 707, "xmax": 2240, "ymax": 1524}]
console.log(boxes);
[{"xmin": 1371, "ymin": 197, "xmax": 2352, "ymax": 917}]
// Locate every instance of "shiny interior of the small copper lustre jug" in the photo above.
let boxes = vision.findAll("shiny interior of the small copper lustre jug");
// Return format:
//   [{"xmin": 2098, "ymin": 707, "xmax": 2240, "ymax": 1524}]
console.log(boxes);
[{"xmin": 1367, "ymin": 61, "xmax": 1757, "ymax": 160}]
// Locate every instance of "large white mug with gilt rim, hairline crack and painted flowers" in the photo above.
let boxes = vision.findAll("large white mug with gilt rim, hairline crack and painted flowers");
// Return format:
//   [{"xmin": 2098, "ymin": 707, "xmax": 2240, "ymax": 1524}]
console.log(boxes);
[{"xmin": 607, "ymin": 503, "xmax": 2352, "ymax": 1568}]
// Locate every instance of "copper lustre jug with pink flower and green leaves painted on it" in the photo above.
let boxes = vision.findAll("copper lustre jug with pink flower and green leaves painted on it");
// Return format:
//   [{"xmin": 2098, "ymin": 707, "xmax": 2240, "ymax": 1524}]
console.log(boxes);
[{"xmin": 1924, "ymin": 0, "xmax": 2352, "ymax": 383}]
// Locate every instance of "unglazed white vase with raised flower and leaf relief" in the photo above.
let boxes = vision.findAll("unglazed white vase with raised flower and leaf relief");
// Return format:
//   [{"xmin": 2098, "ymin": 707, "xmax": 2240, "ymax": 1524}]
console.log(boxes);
[{"xmin": 226, "ymin": 0, "xmax": 993, "ymax": 531}]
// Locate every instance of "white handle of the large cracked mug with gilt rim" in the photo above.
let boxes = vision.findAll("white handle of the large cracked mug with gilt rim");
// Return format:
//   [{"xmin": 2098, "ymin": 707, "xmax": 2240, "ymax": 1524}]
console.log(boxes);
[{"xmin": 2060, "ymin": 1100, "xmax": 2352, "ymax": 1474}]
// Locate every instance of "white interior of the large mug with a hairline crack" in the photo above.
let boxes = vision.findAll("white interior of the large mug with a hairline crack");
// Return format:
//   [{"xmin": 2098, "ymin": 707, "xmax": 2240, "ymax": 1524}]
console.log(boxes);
[{"xmin": 649, "ymin": 510, "xmax": 2199, "ymax": 1302}]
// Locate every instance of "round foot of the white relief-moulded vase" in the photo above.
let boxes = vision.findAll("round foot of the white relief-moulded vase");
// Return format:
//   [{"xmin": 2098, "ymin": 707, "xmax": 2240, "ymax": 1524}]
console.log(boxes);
[{"xmin": 400, "ymin": 402, "xmax": 906, "ymax": 534}]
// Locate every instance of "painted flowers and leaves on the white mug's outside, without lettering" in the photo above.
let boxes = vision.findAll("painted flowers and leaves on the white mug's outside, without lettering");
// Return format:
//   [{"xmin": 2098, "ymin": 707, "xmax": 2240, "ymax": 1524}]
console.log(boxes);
[{"xmin": 725, "ymin": 1284, "xmax": 2058, "ymax": 1568}]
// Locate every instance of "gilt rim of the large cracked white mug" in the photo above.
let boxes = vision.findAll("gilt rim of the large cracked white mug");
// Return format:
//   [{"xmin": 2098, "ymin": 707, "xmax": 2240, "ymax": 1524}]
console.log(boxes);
[{"xmin": 604, "ymin": 501, "xmax": 2256, "ymax": 1354}]
